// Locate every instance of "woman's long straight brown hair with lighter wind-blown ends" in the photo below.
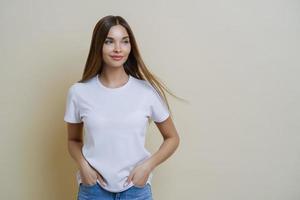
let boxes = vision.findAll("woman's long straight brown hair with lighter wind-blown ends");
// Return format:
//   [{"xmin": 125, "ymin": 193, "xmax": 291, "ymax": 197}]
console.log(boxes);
[{"xmin": 78, "ymin": 15, "xmax": 183, "ymax": 119}]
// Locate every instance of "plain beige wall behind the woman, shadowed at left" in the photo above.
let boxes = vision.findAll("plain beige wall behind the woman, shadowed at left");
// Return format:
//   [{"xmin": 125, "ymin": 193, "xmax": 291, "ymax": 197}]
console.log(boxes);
[{"xmin": 0, "ymin": 0, "xmax": 300, "ymax": 200}]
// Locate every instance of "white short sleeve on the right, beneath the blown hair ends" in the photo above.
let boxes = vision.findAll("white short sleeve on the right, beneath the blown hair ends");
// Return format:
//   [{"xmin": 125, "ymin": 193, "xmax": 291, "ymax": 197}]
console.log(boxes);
[{"xmin": 149, "ymin": 87, "xmax": 170, "ymax": 122}]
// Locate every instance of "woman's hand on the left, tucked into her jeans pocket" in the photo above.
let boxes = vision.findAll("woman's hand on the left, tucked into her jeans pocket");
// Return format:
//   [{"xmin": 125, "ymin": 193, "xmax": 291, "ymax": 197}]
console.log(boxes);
[{"xmin": 79, "ymin": 163, "xmax": 106, "ymax": 187}]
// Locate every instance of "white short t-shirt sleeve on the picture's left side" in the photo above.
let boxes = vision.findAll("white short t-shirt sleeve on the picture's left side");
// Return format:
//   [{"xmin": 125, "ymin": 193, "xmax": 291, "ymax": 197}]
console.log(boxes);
[{"xmin": 64, "ymin": 85, "xmax": 81, "ymax": 123}]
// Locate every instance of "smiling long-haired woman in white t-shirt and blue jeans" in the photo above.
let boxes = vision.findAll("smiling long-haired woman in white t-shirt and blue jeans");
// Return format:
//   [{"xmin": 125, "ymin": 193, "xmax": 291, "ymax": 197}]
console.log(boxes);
[{"xmin": 64, "ymin": 16, "xmax": 179, "ymax": 200}]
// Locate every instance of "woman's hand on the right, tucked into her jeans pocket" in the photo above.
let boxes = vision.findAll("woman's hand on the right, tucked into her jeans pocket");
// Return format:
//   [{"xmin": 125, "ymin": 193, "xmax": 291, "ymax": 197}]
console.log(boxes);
[{"xmin": 125, "ymin": 163, "xmax": 152, "ymax": 187}]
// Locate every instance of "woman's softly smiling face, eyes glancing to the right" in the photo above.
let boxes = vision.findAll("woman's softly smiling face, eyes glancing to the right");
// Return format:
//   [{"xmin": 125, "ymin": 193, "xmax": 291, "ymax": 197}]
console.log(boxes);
[{"xmin": 102, "ymin": 25, "xmax": 131, "ymax": 67}]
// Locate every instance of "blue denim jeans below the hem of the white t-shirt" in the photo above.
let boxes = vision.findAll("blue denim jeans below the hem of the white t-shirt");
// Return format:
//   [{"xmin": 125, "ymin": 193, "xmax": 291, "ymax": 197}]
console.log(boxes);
[{"xmin": 77, "ymin": 182, "xmax": 153, "ymax": 200}]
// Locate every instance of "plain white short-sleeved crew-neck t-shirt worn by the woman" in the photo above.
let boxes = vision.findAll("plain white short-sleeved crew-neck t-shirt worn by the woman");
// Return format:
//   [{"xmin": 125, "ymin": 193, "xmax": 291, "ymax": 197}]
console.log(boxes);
[{"xmin": 64, "ymin": 75, "xmax": 169, "ymax": 192}]
